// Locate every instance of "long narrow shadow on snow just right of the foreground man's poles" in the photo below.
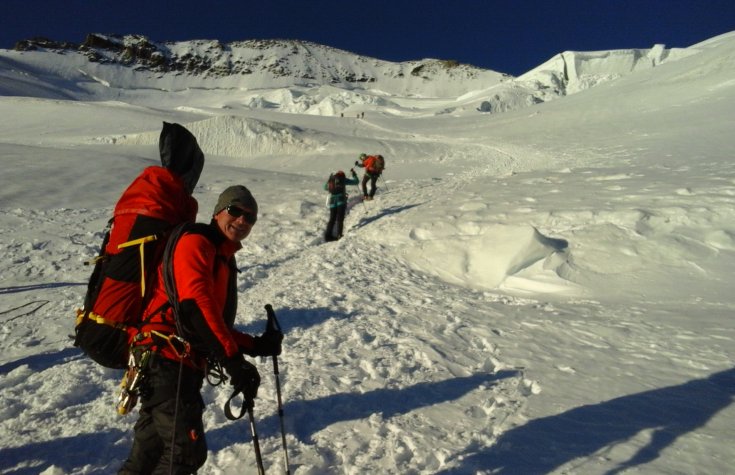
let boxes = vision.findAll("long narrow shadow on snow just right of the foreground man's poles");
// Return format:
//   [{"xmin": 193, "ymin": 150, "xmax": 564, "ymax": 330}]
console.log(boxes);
[{"xmin": 207, "ymin": 371, "xmax": 520, "ymax": 452}]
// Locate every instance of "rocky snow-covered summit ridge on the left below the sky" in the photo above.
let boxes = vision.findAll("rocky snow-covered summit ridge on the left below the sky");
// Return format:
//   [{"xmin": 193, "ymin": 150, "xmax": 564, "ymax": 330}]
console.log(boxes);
[{"xmin": 8, "ymin": 34, "xmax": 505, "ymax": 97}]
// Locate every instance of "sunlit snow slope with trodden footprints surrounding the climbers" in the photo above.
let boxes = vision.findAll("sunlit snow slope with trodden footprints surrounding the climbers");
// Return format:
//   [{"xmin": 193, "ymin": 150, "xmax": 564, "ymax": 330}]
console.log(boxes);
[{"xmin": 0, "ymin": 33, "xmax": 735, "ymax": 475}]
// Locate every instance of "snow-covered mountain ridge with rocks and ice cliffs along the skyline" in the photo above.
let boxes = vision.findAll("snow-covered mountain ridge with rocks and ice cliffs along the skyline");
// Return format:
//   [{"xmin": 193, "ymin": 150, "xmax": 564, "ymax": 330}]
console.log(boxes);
[{"xmin": 0, "ymin": 34, "xmax": 681, "ymax": 115}]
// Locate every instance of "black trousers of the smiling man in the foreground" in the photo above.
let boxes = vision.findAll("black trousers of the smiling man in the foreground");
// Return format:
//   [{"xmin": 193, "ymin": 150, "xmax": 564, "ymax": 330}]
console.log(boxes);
[{"xmin": 118, "ymin": 359, "xmax": 207, "ymax": 475}]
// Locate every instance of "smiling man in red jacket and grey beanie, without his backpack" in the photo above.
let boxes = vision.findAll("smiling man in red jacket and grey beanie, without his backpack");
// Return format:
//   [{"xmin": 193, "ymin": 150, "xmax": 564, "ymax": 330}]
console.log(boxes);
[{"xmin": 119, "ymin": 186, "xmax": 283, "ymax": 474}]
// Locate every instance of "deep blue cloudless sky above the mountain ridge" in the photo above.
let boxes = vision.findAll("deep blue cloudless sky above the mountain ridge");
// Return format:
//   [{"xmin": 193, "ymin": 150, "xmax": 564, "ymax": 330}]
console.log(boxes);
[{"xmin": 0, "ymin": 0, "xmax": 735, "ymax": 76}]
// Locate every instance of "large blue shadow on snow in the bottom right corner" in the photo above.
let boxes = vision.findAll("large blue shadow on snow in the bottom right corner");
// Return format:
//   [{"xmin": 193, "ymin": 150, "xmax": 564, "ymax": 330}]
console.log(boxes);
[{"xmin": 440, "ymin": 368, "xmax": 735, "ymax": 475}]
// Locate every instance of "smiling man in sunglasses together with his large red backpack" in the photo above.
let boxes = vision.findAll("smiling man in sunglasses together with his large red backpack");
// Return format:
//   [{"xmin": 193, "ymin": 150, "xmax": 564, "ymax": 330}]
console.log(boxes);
[{"xmin": 74, "ymin": 122, "xmax": 283, "ymax": 474}]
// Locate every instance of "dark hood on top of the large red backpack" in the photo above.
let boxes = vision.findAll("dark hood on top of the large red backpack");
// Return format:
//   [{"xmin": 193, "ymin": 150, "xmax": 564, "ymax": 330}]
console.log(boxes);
[{"xmin": 158, "ymin": 122, "xmax": 204, "ymax": 194}]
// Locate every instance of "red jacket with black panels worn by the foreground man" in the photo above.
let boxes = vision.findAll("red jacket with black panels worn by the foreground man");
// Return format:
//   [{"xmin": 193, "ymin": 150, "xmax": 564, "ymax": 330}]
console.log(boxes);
[{"xmin": 141, "ymin": 224, "xmax": 253, "ymax": 366}]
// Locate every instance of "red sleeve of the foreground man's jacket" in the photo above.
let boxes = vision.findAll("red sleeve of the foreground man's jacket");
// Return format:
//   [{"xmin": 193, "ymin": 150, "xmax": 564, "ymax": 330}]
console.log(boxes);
[{"xmin": 173, "ymin": 234, "xmax": 239, "ymax": 357}]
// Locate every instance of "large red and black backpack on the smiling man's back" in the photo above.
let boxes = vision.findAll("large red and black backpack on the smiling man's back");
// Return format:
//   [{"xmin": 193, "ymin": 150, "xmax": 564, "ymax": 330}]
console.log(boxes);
[{"xmin": 74, "ymin": 122, "xmax": 204, "ymax": 369}]
